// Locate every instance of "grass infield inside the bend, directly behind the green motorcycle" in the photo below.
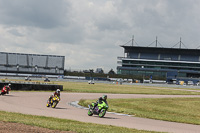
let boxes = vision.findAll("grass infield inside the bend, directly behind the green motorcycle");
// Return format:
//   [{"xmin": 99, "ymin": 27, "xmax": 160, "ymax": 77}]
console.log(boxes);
[{"xmin": 79, "ymin": 98, "xmax": 200, "ymax": 125}]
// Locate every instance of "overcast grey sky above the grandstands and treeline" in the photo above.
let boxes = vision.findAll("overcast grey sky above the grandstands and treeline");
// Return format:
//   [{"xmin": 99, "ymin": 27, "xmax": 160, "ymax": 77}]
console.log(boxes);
[{"xmin": 0, "ymin": 0, "xmax": 200, "ymax": 72}]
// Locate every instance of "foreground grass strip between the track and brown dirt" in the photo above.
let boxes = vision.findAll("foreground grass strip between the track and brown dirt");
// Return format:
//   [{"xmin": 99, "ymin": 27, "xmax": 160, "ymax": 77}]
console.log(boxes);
[{"xmin": 0, "ymin": 111, "xmax": 160, "ymax": 133}]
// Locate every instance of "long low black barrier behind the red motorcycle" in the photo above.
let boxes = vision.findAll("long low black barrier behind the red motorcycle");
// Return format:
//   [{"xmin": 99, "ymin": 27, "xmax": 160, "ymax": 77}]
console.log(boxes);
[{"xmin": 0, "ymin": 83, "xmax": 63, "ymax": 91}]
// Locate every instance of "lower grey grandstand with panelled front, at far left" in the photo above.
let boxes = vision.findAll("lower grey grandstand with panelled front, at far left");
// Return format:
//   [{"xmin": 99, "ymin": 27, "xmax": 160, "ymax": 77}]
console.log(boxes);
[{"xmin": 0, "ymin": 52, "xmax": 65, "ymax": 75}]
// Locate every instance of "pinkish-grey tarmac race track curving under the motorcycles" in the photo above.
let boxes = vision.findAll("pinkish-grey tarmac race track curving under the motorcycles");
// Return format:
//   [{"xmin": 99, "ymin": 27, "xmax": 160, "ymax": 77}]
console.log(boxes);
[{"xmin": 0, "ymin": 92, "xmax": 200, "ymax": 133}]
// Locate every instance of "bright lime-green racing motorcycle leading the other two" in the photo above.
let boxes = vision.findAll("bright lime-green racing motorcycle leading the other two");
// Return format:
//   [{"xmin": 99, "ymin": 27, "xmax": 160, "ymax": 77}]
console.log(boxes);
[{"xmin": 88, "ymin": 101, "xmax": 108, "ymax": 118}]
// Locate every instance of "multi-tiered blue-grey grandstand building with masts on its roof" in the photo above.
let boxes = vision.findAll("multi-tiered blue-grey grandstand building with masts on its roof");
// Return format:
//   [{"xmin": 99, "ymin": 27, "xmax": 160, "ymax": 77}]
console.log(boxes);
[{"xmin": 117, "ymin": 46, "xmax": 200, "ymax": 78}]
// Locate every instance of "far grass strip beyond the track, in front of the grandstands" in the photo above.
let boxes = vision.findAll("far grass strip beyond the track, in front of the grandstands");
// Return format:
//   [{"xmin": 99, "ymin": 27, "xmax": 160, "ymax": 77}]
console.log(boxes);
[{"xmin": 56, "ymin": 82, "xmax": 200, "ymax": 95}]
